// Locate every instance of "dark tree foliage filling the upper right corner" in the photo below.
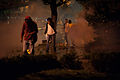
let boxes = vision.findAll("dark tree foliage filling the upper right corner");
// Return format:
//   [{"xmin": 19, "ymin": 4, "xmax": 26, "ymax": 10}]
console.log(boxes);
[{"xmin": 76, "ymin": 0, "xmax": 120, "ymax": 22}]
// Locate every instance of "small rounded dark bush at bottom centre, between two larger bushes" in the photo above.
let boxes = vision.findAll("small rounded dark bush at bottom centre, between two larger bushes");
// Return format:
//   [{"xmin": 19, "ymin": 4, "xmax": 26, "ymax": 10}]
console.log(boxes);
[{"xmin": 60, "ymin": 53, "xmax": 82, "ymax": 69}]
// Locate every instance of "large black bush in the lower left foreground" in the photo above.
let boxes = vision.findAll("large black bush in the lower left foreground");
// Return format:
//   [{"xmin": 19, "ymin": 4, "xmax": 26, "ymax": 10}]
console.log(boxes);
[{"xmin": 0, "ymin": 55, "xmax": 61, "ymax": 78}]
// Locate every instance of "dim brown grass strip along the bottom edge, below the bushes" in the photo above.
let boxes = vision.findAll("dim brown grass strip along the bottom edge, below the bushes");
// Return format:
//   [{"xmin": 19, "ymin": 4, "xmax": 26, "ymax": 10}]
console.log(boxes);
[{"xmin": 18, "ymin": 69, "xmax": 107, "ymax": 80}]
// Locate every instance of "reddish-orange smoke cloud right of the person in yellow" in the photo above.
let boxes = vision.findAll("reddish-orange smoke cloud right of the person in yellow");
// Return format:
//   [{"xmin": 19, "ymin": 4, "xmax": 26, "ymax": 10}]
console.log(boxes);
[{"xmin": 69, "ymin": 9, "xmax": 96, "ymax": 55}]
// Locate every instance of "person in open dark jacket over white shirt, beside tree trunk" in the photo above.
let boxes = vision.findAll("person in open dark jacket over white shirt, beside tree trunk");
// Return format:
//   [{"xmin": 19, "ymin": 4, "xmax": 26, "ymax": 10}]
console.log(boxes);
[{"xmin": 44, "ymin": 18, "xmax": 56, "ymax": 53}]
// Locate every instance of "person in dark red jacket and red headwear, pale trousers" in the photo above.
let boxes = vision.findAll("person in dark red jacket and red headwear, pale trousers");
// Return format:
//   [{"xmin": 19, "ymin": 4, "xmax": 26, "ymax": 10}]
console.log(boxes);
[{"xmin": 21, "ymin": 16, "xmax": 38, "ymax": 55}]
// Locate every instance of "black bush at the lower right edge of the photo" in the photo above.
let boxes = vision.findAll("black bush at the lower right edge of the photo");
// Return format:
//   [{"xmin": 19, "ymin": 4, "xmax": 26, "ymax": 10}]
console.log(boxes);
[{"xmin": 90, "ymin": 52, "xmax": 120, "ymax": 73}]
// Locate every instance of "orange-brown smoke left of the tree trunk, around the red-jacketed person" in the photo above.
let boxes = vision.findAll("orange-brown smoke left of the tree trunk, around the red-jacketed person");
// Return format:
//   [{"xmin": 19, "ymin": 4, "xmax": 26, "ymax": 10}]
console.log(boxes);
[{"xmin": 0, "ymin": 2, "xmax": 50, "ymax": 58}]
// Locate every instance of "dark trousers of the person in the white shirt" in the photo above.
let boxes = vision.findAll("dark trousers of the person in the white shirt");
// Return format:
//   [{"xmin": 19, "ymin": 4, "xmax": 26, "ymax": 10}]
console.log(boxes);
[{"xmin": 46, "ymin": 35, "xmax": 56, "ymax": 52}]
